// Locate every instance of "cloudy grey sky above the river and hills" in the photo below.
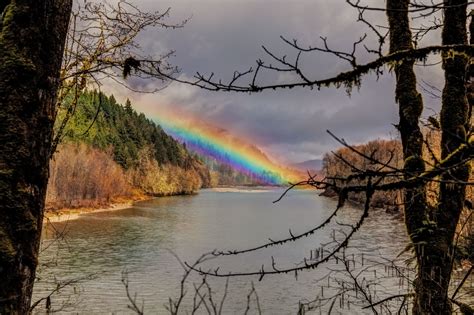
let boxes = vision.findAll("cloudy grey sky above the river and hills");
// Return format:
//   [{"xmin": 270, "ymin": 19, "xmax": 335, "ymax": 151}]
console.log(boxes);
[{"xmin": 103, "ymin": 0, "xmax": 443, "ymax": 163}]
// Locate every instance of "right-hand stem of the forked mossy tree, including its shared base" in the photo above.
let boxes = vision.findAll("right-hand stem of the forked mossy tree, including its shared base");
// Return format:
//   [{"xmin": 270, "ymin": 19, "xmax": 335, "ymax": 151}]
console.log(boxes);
[{"xmin": 414, "ymin": 0, "xmax": 469, "ymax": 315}]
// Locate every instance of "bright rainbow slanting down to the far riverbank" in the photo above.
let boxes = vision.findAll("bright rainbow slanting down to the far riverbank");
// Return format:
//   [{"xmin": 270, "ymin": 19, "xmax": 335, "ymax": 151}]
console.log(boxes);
[{"xmin": 153, "ymin": 111, "xmax": 301, "ymax": 185}]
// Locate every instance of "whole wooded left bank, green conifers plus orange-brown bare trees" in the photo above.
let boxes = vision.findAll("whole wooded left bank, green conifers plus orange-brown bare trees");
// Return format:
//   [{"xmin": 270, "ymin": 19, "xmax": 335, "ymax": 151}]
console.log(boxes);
[{"xmin": 47, "ymin": 91, "xmax": 211, "ymax": 208}]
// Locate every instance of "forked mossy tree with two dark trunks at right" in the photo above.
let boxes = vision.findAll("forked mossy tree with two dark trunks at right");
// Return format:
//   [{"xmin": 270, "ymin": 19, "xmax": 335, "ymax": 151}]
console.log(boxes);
[{"xmin": 387, "ymin": 0, "xmax": 469, "ymax": 314}]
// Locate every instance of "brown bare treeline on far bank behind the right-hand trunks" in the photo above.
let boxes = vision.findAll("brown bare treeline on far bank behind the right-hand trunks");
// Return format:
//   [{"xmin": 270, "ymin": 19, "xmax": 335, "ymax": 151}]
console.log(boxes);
[{"xmin": 322, "ymin": 134, "xmax": 474, "ymax": 262}]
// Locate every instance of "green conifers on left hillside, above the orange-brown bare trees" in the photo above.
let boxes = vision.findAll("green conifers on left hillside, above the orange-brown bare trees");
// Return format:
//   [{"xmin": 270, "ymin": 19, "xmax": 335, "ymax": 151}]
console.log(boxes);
[{"xmin": 59, "ymin": 91, "xmax": 189, "ymax": 169}]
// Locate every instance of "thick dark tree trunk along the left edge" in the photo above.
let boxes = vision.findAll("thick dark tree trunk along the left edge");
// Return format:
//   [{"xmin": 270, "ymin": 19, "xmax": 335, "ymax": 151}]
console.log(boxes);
[{"xmin": 0, "ymin": 0, "xmax": 72, "ymax": 314}]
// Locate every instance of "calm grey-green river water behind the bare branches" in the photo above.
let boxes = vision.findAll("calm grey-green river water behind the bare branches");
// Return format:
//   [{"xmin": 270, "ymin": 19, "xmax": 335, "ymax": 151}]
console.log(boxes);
[{"xmin": 33, "ymin": 188, "xmax": 412, "ymax": 314}]
